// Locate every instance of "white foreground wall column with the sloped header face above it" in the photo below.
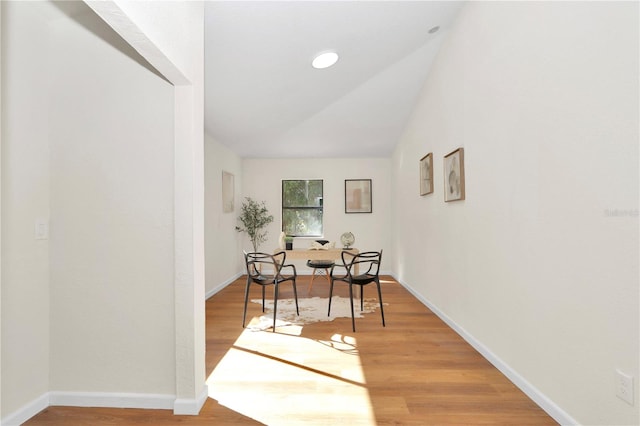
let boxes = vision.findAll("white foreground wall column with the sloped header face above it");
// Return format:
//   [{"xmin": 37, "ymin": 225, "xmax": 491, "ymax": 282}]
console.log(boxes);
[{"xmin": 65, "ymin": 0, "xmax": 207, "ymax": 414}]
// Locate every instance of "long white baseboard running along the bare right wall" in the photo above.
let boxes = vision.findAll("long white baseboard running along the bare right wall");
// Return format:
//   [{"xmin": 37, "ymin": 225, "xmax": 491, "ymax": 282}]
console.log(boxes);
[{"xmin": 394, "ymin": 276, "xmax": 579, "ymax": 425}]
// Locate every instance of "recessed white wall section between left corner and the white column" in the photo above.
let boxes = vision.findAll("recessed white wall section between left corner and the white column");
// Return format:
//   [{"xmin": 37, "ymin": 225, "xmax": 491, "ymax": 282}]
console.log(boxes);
[{"xmin": 47, "ymin": 3, "xmax": 175, "ymax": 395}]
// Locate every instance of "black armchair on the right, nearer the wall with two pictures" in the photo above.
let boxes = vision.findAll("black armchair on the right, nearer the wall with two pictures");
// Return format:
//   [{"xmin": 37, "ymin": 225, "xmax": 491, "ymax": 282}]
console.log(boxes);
[{"xmin": 327, "ymin": 250, "xmax": 385, "ymax": 332}]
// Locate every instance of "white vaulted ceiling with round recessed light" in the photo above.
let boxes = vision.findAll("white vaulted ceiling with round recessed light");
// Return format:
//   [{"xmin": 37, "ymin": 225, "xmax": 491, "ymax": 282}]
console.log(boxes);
[{"xmin": 205, "ymin": 1, "xmax": 462, "ymax": 158}]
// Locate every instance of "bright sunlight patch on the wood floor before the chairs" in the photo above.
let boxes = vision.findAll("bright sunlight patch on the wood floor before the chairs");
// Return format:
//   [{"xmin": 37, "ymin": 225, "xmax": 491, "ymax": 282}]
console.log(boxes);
[{"xmin": 207, "ymin": 327, "xmax": 376, "ymax": 425}]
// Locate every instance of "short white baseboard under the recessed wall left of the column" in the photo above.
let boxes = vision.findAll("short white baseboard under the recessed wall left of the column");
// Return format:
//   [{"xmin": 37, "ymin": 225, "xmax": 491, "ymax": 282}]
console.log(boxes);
[{"xmin": 49, "ymin": 391, "xmax": 176, "ymax": 410}]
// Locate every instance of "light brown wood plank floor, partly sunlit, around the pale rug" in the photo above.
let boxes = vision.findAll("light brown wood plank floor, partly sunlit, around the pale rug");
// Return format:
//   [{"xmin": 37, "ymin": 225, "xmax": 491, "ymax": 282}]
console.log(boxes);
[{"xmin": 25, "ymin": 276, "xmax": 557, "ymax": 426}]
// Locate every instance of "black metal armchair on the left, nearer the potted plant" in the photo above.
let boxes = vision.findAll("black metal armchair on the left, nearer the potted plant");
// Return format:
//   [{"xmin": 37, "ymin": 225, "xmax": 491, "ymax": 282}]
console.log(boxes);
[{"xmin": 242, "ymin": 251, "xmax": 300, "ymax": 332}]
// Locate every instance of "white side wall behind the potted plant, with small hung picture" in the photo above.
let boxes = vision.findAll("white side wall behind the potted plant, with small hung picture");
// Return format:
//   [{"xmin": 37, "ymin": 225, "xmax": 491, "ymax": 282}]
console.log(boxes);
[{"xmin": 204, "ymin": 134, "xmax": 244, "ymax": 296}]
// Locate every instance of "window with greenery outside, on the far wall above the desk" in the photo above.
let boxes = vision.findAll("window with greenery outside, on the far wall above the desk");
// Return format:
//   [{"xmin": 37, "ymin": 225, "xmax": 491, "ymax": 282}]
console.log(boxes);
[{"xmin": 282, "ymin": 179, "xmax": 322, "ymax": 237}]
